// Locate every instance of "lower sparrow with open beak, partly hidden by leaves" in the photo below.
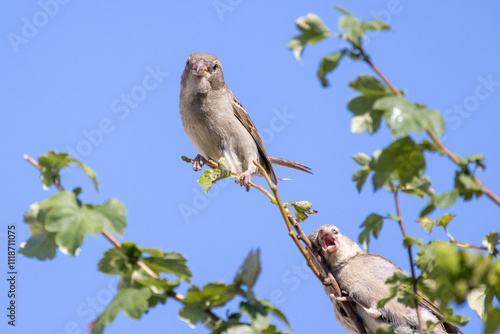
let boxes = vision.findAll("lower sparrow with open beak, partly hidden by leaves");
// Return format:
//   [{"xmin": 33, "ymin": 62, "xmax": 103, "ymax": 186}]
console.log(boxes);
[{"xmin": 309, "ymin": 225, "xmax": 461, "ymax": 334}]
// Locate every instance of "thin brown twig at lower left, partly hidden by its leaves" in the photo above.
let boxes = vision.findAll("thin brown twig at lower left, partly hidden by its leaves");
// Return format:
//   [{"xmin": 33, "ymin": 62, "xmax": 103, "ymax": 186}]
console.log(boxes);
[{"xmin": 23, "ymin": 154, "xmax": 222, "ymax": 329}]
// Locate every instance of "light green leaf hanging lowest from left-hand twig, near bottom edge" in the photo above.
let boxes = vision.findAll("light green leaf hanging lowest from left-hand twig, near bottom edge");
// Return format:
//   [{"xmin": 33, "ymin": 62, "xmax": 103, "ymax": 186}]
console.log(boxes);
[{"xmin": 92, "ymin": 288, "xmax": 151, "ymax": 334}]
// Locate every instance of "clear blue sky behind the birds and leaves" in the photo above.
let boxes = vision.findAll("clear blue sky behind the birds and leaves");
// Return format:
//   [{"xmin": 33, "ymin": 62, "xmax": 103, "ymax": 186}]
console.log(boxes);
[{"xmin": 0, "ymin": 0, "xmax": 500, "ymax": 334}]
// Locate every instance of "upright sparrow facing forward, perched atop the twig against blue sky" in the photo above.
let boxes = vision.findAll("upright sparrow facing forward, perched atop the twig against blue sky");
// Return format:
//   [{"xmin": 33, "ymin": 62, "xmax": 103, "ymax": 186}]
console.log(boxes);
[{"xmin": 179, "ymin": 53, "xmax": 312, "ymax": 191}]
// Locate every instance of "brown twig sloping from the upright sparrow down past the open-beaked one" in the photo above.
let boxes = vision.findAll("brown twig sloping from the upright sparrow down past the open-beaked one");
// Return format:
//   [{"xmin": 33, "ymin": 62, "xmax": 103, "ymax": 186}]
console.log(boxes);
[{"xmin": 253, "ymin": 161, "xmax": 366, "ymax": 334}]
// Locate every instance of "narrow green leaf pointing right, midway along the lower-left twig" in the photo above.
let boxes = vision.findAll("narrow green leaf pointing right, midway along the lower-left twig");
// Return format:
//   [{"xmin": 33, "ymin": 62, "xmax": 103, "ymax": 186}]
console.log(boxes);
[{"xmin": 144, "ymin": 248, "xmax": 192, "ymax": 283}]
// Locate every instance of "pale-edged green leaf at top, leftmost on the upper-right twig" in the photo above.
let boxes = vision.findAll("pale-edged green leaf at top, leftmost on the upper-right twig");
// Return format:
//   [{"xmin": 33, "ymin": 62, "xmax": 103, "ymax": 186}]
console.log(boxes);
[{"xmin": 288, "ymin": 14, "xmax": 331, "ymax": 61}]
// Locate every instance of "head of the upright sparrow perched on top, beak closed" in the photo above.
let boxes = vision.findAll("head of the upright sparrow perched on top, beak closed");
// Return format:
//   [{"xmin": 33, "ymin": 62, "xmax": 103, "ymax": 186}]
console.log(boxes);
[{"xmin": 181, "ymin": 52, "xmax": 225, "ymax": 94}]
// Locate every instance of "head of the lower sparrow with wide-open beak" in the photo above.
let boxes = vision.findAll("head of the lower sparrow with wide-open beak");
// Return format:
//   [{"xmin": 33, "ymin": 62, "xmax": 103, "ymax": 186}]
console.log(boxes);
[{"xmin": 309, "ymin": 225, "xmax": 362, "ymax": 266}]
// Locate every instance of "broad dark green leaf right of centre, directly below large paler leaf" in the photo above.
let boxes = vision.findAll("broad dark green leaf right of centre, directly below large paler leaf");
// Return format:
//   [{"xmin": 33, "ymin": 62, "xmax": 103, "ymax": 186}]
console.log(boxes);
[{"xmin": 370, "ymin": 137, "xmax": 425, "ymax": 190}]
